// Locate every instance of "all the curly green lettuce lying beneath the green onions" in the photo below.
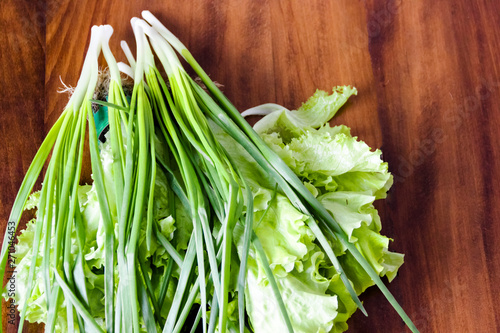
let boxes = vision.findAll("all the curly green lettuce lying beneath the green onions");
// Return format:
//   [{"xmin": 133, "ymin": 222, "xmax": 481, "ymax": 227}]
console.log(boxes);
[{"xmin": 9, "ymin": 87, "xmax": 403, "ymax": 333}]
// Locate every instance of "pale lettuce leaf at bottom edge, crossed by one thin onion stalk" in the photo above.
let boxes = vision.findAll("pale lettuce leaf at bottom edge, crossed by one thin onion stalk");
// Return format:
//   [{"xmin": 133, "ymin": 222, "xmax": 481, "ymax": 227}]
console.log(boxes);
[{"xmin": 234, "ymin": 189, "xmax": 338, "ymax": 333}]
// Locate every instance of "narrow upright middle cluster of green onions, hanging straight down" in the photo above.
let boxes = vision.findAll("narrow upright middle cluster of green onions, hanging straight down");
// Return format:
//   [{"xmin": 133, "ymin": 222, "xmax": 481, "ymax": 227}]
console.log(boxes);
[{"xmin": 110, "ymin": 20, "xmax": 156, "ymax": 332}]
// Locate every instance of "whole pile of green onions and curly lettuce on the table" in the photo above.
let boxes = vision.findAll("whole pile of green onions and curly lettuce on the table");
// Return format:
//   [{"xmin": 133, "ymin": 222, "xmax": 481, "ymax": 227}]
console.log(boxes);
[{"xmin": 0, "ymin": 11, "xmax": 417, "ymax": 332}]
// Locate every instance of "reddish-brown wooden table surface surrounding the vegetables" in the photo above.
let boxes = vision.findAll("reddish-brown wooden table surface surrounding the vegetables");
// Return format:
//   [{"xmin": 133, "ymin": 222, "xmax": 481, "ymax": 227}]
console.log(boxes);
[{"xmin": 0, "ymin": 0, "xmax": 500, "ymax": 333}]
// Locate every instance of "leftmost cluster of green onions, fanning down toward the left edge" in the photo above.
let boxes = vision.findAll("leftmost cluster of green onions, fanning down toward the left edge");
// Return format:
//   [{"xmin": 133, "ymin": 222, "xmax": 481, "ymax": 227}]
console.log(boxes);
[{"xmin": 0, "ymin": 27, "xmax": 105, "ymax": 332}]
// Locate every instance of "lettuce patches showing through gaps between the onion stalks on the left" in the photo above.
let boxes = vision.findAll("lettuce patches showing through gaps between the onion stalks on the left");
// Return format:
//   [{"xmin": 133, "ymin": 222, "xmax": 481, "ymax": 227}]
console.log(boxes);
[{"xmin": 8, "ymin": 139, "xmax": 184, "ymax": 332}]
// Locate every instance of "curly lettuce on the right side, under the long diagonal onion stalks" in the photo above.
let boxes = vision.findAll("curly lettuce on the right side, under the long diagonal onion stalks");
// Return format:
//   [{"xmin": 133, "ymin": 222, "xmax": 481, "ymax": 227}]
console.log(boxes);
[{"xmin": 221, "ymin": 87, "xmax": 403, "ymax": 333}]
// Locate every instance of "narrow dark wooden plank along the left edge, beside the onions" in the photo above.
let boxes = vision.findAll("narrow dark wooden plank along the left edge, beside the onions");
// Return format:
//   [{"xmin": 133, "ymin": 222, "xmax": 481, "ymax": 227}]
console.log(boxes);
[{"xmin": 0, "ymin": 0, "xmax": 45, "ymax": 332}]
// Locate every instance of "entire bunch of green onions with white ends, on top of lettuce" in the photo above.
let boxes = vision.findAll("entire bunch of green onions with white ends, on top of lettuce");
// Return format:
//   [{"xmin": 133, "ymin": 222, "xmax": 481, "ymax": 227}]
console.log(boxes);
[{"xmin": 0, "ymin": 11, "xmax": 417, "ymax": 332}]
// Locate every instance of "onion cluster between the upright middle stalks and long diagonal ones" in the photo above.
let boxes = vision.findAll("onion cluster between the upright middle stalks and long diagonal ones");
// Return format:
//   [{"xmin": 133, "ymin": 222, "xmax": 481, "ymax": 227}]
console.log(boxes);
[{"xmin": 122, "ymin": 19, "xmax": 308, "ymax": 332}]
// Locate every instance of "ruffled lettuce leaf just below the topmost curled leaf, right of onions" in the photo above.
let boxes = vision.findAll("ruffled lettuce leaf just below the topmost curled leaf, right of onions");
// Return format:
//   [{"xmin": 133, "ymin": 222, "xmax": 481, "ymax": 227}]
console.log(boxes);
[{"xmin": 262, "ymin": 124, "xmax": 392, "ymax": 198}]
